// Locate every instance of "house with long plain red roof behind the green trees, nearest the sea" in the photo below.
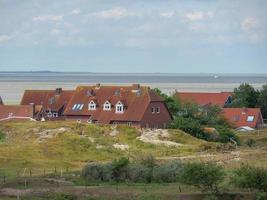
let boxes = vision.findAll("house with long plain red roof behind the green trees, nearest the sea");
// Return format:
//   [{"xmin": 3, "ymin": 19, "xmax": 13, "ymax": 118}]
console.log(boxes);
[{"xmin": 176, "ymin": 92, "xmax": 232, "ymax": 108}]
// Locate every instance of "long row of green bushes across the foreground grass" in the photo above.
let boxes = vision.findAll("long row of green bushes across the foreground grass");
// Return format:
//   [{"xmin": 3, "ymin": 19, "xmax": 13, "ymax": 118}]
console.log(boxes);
[{"xmin": 82, "ymin": 156, "xmax": 267, "ymax": 199}]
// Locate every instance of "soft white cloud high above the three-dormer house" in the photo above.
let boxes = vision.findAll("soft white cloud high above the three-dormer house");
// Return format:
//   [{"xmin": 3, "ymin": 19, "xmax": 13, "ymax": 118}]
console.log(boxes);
[{"xmin": 92, "ymin": 7, "xmax": 134, "ymax": 19}]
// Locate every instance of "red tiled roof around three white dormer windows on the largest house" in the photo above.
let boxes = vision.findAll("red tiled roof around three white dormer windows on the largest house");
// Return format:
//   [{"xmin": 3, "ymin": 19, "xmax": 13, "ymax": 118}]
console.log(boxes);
[{"xmin": 64, "ymin": 85, "xmax": 163, "ymax": 123}]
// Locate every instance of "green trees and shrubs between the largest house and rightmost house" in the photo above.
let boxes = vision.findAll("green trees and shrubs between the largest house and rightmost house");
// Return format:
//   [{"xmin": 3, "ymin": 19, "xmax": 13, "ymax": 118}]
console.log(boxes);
[{"xmin": 154, "ymin": 89, "xmax": 238, "ymax": 143}]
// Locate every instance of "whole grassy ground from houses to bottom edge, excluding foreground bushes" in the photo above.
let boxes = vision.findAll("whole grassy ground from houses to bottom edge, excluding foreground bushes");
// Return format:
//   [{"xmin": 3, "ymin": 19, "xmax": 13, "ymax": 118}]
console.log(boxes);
[{"xmin": 0, "ymin": 121, "xmax": 267, "ymax": 200}]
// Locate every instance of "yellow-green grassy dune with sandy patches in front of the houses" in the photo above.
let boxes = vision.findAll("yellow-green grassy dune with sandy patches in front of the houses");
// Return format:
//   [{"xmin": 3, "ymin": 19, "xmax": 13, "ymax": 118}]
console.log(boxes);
[{"xmin": 0, "ymin": 121, "xmax": 209, "ymax": 174}]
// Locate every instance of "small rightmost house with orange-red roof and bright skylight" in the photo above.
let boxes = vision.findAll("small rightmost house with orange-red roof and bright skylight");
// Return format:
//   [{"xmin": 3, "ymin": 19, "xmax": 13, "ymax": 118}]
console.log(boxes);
[{"xmin": 222, "ymin": 108, "xmax": 264, "ymax": 128}]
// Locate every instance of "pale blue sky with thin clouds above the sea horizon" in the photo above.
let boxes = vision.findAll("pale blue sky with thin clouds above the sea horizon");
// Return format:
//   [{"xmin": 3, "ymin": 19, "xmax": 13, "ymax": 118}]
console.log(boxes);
[{"xmin": 0, "ymin": 0, "xmax": 267, "ymax": 73}]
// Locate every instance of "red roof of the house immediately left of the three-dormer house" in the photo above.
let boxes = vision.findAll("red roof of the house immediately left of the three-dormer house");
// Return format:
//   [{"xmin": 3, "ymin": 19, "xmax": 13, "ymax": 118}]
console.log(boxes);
[{"xmin": 20, "ymin": 89, "xmax": 74, "ymax": 111}]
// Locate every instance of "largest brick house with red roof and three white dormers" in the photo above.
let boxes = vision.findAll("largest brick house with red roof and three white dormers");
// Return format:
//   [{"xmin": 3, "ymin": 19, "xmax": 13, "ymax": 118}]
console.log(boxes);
[{"xmin": 64, "ymin": 84, "xmax": 171, "ymax": 128}]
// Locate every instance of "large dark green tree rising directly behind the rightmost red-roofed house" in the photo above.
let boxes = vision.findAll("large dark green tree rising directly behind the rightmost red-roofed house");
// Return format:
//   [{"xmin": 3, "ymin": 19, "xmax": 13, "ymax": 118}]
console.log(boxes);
[{"xmin": 231, "ymin": 83, "xmax": 259, "ymax": 108}]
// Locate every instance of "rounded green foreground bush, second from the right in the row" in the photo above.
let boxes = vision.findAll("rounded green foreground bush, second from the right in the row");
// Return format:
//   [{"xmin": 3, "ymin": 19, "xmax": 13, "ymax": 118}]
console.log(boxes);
[{"xmin": 180, "ymin": 163, "xmax": 224, "ymax": 193}]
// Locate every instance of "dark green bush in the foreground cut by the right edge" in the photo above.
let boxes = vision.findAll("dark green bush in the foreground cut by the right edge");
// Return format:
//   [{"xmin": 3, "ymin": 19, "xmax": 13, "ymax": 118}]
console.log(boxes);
[{"xmin": 231, "ymin": 165, "xmax": 267, "ymax": 192}]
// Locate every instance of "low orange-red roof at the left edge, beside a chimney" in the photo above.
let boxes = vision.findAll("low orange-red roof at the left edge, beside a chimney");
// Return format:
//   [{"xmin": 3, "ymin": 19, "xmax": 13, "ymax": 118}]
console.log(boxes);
[{"xmin": 0, "ymin": 105, "xmax": 33, "ymax": 121}]
